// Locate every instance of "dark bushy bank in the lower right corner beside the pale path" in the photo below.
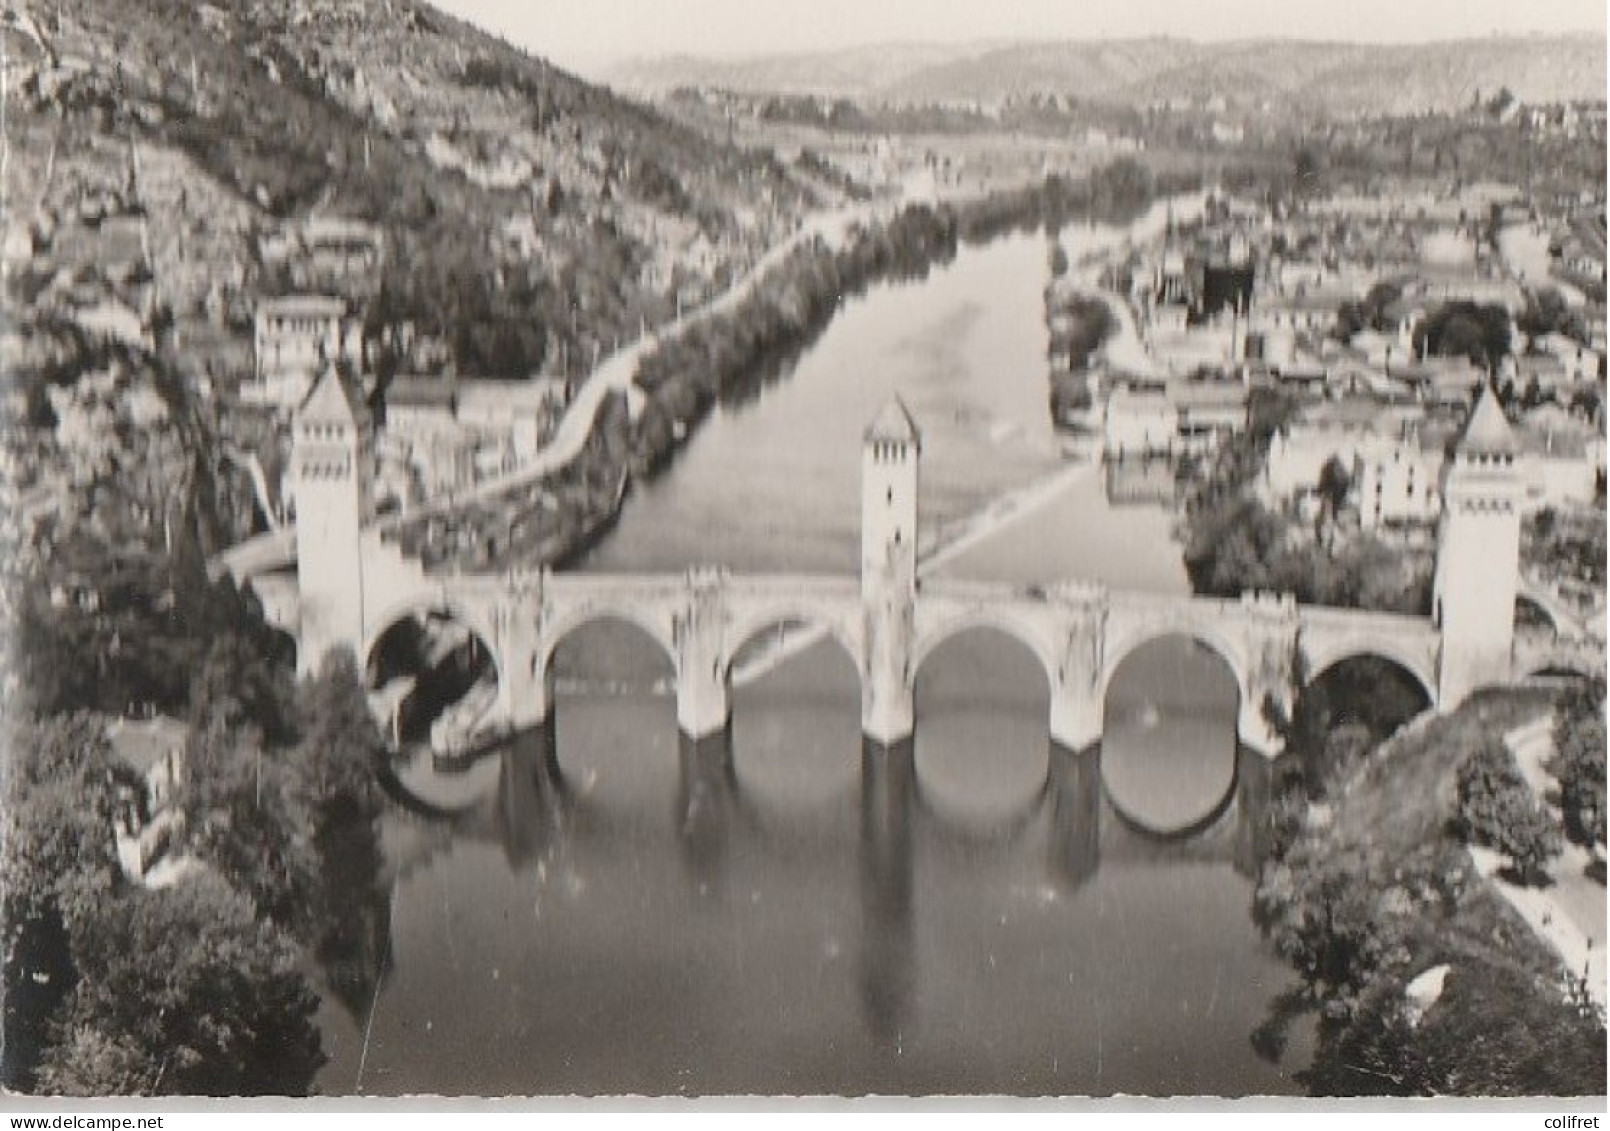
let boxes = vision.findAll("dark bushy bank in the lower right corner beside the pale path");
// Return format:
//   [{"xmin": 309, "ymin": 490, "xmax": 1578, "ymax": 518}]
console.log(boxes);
[{"xmin": 1253, "ymin": 694, "xmax": 1605, "ymax": 1096}]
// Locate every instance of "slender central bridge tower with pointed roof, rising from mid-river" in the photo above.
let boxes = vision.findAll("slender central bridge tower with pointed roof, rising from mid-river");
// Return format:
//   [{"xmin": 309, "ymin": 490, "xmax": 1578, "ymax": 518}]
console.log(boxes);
[{"xmin": 861, "ymin": 396, "xmax": 923, "ymax": 746}]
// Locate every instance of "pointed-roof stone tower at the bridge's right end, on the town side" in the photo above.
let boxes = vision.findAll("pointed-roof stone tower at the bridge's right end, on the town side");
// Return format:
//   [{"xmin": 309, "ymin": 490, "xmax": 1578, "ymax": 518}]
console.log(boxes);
[{"xmin": 1431, "ymin": 383, "xmax": 1525, "ymax": 711}]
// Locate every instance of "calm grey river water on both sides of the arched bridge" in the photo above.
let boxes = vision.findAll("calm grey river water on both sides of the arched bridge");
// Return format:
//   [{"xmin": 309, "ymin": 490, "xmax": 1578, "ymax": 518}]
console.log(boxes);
[{"xmin": 319, "ymin": 201, "xmax": 1298, "ymax": 1096}]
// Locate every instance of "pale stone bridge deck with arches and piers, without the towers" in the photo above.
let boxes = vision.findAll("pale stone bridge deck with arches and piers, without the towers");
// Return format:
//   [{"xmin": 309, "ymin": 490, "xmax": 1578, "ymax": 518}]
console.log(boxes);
[{"xmin": 349, "ymin": 569, "xmax": 1441, "ymax": 766}]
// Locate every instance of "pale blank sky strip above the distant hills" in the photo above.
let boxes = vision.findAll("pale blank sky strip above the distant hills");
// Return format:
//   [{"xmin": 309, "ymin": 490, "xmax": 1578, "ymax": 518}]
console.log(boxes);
[{"xmin": 433, "ymin": 0, "xmax": 1605, "ymax": 73}]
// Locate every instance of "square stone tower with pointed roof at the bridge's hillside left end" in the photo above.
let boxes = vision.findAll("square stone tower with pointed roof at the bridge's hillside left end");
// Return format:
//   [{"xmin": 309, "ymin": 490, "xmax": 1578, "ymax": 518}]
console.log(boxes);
[{"xmin": 291, "ymin": 366, "xmax": 370, "ymax": 675}]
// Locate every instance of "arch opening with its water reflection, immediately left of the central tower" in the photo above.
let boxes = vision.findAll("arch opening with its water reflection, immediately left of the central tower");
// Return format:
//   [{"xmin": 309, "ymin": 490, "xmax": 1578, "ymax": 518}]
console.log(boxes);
[{"xmin": 725, "ymin": 612, "xmax": 863, "ymax": 817}]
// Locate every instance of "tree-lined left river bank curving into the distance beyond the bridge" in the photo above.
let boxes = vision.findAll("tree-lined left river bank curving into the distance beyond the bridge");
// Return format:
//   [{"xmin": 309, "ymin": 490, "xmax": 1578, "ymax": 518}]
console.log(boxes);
[{"xmin": 386, "ymin": 163, "xmax": 1185, "ymax": 569}]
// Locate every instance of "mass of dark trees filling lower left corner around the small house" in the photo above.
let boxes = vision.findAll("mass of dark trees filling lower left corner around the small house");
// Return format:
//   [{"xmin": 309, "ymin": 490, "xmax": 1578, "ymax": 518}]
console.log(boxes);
[{"xmin": 0, "ymin": 540, "xmax": 383, "ymax": 1094}]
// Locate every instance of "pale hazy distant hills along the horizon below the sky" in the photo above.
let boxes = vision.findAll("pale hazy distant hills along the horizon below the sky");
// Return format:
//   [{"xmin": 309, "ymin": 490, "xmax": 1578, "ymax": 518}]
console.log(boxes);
[{"xmin": 599, "ymin": 34, "xmax": 1605, "ymax": 113}]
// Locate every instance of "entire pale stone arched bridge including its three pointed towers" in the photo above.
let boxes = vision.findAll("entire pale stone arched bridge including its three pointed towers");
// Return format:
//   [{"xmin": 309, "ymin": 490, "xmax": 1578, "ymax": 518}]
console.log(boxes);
[{"xmin": 291, "ymin": 385, "xmax": 1520, "ymax": 766}]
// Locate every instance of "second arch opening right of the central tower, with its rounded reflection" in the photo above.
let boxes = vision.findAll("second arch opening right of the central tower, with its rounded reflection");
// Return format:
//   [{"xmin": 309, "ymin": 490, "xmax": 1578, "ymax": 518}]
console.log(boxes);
[{"xmin": 1100, "ymin": 630, "xmax": 1246, "ymax": 839}]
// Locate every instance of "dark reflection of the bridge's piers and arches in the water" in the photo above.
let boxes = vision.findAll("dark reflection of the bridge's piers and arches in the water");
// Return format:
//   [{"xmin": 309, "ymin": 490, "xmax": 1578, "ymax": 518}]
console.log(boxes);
[{"xmin": 376, "ymin": 727, "xmax": 1270, "ymax": 1038}]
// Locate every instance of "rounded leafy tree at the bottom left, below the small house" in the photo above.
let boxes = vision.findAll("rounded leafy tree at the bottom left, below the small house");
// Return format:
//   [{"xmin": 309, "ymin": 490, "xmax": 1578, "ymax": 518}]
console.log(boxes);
[{"xmin": 40, "ymin": 873, "xmax": 324, "ymax": 1096}]
